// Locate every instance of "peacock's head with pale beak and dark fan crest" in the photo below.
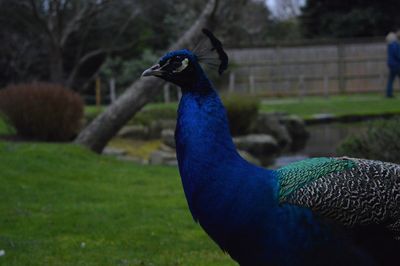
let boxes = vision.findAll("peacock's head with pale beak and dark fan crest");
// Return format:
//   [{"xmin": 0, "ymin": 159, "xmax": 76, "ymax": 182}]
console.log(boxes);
[{"xmin": 142, "ymin": 29, "xmax": 228, "ymax": 89}]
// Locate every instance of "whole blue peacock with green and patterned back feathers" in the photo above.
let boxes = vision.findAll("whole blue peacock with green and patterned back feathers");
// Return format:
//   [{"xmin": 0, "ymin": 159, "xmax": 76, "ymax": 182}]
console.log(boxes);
[{"xmin": 142, "ymin": 29, "xmax": 400, "ymax": 266}]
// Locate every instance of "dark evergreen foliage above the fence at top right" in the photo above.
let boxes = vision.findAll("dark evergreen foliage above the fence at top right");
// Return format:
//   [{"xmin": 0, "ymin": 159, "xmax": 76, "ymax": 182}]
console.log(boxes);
[{"xmin": 300, "ymin": 0, "xmax": 400, "ymax": 38}]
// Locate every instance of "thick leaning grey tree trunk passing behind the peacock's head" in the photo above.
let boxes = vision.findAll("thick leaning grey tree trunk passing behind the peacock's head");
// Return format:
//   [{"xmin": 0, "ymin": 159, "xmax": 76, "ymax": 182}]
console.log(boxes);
[{"xmin": 75, "ymin": 0, "xmax": 218, "ymax": 153}]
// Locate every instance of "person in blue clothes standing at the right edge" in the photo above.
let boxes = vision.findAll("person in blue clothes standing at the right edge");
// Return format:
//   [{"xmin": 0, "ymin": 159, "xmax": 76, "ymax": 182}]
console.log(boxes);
[{"xmin": 386, "ymin": 31, "xmax": 400, "ymax": 98}]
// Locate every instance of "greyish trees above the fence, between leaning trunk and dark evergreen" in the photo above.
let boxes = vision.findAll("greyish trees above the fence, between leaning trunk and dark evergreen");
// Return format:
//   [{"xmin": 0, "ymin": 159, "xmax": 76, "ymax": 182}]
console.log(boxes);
[{"xmin": 217, "ymin": 0, "xmax": 301, "ymax": 47}]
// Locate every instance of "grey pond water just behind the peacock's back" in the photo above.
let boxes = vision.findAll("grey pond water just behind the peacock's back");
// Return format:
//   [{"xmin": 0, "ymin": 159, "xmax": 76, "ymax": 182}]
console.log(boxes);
[{"xmin": 272, "ymin": 123, "xmax": 366, "ymax": 168}]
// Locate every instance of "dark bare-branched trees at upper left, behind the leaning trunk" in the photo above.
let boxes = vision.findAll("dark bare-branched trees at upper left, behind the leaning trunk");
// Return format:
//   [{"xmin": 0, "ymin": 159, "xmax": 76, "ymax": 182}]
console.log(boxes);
[{"xmin": 0, "ymin": 0, "xmax": 188, "ymax": 91}]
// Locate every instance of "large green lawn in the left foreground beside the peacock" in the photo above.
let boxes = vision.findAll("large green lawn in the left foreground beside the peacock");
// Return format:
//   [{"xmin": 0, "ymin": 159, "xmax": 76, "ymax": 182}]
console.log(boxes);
[{"xmin": 0, "ymin": 142, "xmax": 235, "ymax": 266}]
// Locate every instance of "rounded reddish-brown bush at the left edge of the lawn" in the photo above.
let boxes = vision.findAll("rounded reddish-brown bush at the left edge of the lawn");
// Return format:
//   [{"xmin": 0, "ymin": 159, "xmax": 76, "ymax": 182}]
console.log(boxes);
[{"xmin": 0, "ymin": 83, "xmax": 84, "ymax": 141}]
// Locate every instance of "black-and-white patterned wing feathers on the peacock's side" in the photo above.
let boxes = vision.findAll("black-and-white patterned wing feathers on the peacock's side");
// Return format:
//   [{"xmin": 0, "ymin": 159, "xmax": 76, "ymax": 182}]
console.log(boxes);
[{"xmin": 280, "ymin": 158, "xmax": 400, "ymax": 235}]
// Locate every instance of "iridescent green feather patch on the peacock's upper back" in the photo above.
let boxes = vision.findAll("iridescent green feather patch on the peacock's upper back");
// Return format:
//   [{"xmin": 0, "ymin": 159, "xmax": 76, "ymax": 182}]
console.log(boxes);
[{"xmin": 277, "ymin": 157, "xmax": 355, "ymax": 201}]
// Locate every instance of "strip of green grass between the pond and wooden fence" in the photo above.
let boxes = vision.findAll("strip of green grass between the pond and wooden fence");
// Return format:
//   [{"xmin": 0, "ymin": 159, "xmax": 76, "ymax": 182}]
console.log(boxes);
[{"xmin": 261, "ymin": 94, "xmax": 400, "ymax": 118}]
